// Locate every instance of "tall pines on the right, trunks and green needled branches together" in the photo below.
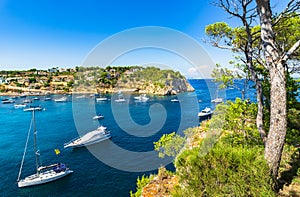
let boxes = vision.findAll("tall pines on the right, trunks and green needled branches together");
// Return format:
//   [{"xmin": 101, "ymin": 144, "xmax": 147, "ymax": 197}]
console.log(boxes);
[{"xmin": 205, "ymin": 0, "xmax": 300, "ymax": 178}]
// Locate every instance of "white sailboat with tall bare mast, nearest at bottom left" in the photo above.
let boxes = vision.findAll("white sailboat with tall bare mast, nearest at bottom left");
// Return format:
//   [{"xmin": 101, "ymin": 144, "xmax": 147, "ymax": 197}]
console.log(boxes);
[{"xmin": 17, "ymin": 110, "xmax": 73, "ymax": 188}]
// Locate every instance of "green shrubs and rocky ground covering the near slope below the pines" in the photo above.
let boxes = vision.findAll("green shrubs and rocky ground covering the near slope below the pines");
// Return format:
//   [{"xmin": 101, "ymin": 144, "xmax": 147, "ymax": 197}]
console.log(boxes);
[{"xmin": 131, "ymin": 99, "xmax": 300, "ymax": 197}]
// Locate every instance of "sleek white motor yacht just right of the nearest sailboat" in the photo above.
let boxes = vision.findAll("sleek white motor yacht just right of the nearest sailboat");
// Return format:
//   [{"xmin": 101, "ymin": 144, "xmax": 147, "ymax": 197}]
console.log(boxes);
[{"xmin": 64, "ymin": 126, "xmax": 111, "ymax": 148}]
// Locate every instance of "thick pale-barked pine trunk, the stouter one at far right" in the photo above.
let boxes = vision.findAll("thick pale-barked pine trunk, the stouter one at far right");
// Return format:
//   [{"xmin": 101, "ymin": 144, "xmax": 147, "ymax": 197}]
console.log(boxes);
[{"xmin": 256, "ymin": 0, "xmax": 287, "ymax": 178}]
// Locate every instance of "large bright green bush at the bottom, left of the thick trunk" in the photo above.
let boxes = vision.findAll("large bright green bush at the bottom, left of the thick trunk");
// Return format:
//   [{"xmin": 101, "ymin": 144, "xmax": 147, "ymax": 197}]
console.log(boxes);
[{"xmin": 174, "ymin": 141, "xmax": 275, "ymax": 197}]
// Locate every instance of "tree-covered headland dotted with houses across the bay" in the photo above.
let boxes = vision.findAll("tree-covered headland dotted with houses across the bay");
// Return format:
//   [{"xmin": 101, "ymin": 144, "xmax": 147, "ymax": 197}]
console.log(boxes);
[{"xmin": 0, "ymin": 66, "xmax": 194, "ymax": 95}]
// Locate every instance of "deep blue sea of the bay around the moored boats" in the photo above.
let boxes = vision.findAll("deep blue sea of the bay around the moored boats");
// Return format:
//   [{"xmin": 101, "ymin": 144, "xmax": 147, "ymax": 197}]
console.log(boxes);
[{"xmin": 0, "ymin": 79, "xmax": 255, "ymax": 197}]
